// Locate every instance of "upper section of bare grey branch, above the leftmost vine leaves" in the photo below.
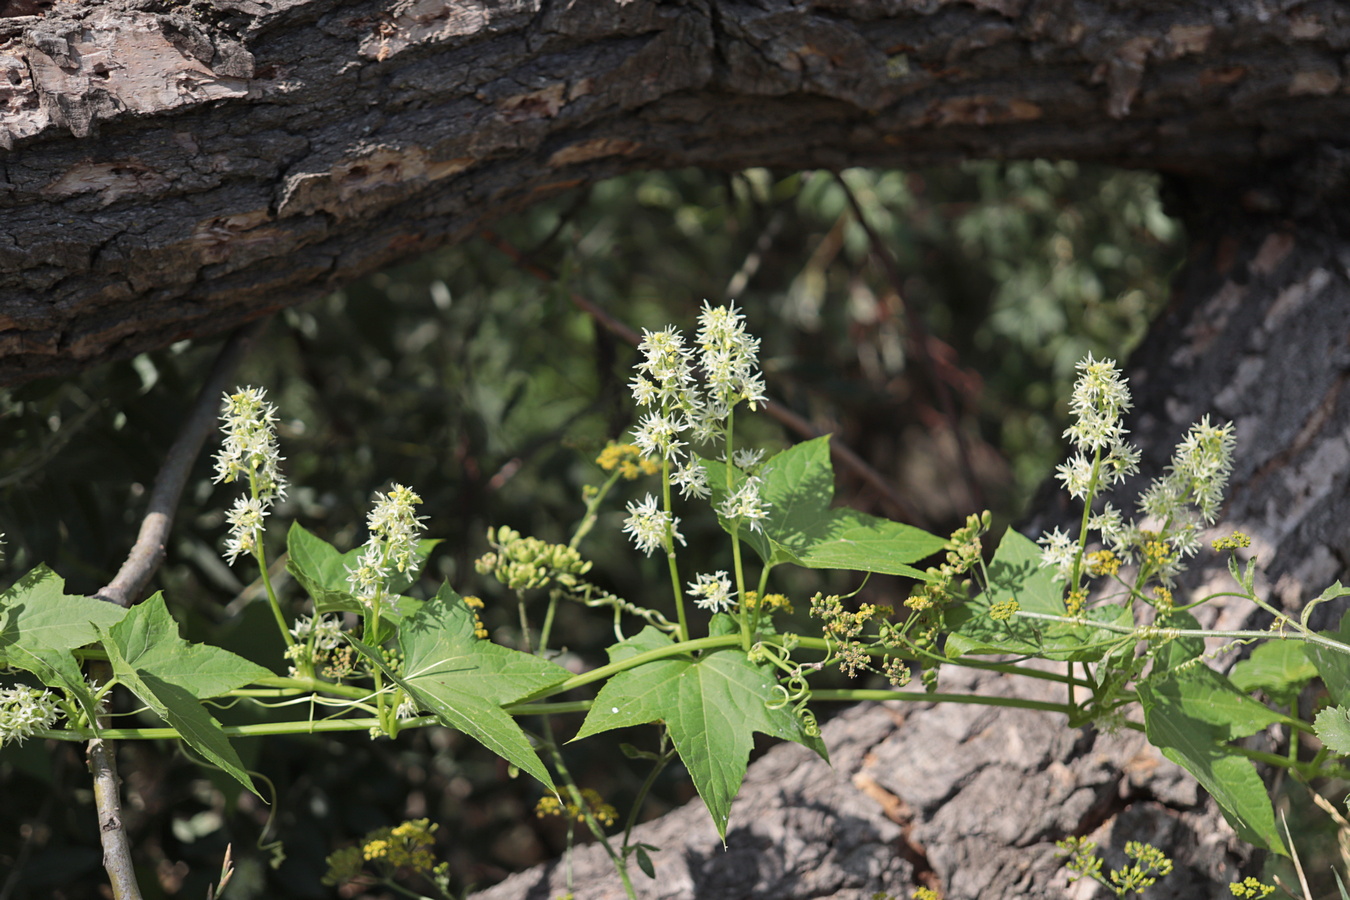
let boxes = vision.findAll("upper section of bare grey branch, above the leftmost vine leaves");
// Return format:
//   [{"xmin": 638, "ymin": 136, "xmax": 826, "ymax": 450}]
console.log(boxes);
[{"xmin": 95, "ymin": 318, "xmax": 267, "ymax": 606}]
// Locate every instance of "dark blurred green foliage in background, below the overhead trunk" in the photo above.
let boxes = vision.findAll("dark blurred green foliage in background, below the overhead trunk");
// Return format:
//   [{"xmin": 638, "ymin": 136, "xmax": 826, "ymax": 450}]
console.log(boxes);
[{"xmin": 0, "ymin": 162, "xmax": 1181, "ymax": 899}]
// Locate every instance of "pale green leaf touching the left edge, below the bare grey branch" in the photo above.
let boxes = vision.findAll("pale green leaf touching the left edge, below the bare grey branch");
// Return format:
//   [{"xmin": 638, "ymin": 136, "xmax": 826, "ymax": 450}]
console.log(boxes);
[{"xmin": 0, "ymin": 565, "xmax": 127, "ymax": 665}]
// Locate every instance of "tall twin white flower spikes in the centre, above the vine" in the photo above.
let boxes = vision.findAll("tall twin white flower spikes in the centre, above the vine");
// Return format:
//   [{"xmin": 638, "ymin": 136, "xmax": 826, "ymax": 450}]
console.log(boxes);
[{"xmin": 624, "ymin": 301, "xmax": 768, "ymax": 555}]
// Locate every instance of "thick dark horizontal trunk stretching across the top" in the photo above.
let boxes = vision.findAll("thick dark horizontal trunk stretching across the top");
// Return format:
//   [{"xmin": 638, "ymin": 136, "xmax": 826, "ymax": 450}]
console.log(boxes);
[{"xmin": 0, "ymin": 0, "xmax": 1350, "ymax": 383}]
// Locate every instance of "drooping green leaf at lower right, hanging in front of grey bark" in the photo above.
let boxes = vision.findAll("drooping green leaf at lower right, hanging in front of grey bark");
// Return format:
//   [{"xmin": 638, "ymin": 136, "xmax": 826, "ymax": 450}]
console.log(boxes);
[{"xmin": 1138, "ymin": 665, "xmax": 1288, "ymax": 854}]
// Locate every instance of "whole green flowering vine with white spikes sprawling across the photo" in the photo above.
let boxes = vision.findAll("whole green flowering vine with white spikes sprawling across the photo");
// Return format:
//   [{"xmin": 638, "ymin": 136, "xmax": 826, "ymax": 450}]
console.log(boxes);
[{"xmin": 0, "ymin": 305, "xmax": 1350, "ymax": 896}]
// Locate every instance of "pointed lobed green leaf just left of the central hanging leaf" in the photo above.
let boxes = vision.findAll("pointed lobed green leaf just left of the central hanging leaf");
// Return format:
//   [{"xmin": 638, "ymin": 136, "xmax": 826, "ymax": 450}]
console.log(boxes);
[{"xmin": 352, "ymin": 586, "xmax": 571, "ymax": 787}]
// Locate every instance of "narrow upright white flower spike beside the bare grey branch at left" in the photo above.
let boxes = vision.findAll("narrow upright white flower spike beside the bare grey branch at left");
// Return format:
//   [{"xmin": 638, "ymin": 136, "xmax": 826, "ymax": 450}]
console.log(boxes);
[{"xmin": 215, "ymin": 387, "xmax": 286, "ymax": 563}]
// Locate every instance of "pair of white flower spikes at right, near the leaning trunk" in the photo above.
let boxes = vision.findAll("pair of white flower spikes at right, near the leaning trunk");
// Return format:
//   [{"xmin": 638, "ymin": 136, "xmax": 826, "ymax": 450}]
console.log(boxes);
[{"xmin": 1040, "ymin": 355, "xmax": 1234, "ymax": 584}]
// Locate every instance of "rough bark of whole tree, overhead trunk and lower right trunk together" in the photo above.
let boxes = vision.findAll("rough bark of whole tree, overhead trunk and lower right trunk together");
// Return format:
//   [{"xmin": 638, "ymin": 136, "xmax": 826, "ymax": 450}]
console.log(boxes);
[{"xmin": 0, "ymin": 0, "xmax": 1350, "ymax": 900}]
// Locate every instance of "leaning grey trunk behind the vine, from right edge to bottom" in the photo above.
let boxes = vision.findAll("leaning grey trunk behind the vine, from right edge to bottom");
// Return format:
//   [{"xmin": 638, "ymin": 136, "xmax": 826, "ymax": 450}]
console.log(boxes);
[{"xmin": 477, "ymin": 172, "xmax": 1350, "ymax": 900}]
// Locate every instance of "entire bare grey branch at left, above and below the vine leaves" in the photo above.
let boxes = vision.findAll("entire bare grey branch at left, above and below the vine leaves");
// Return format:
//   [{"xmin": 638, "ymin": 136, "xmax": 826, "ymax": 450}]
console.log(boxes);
[{"xmin": 88, "ymin": 320, "xmax": 266, "ymax": 900}]
